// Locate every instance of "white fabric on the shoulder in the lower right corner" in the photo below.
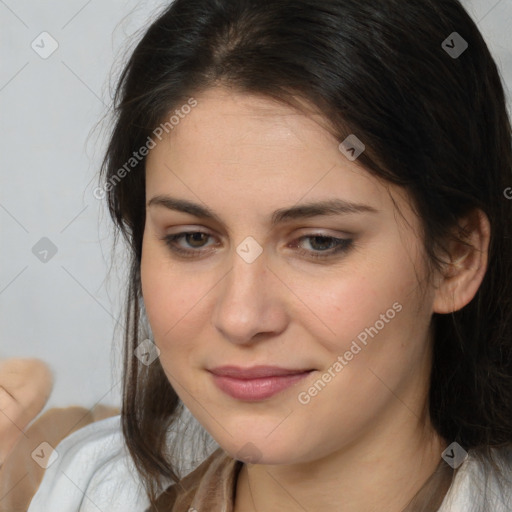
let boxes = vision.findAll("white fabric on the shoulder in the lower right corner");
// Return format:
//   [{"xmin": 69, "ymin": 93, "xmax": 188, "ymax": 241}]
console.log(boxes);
[{"xmin": 438, "ymin": 445, "xmax": 512, "ymax": 512}]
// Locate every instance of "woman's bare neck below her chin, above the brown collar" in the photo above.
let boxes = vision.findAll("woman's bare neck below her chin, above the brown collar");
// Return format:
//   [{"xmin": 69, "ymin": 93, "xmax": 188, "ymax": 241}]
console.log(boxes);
[{"xmin": 235, "ymin": 404, "xmax": 447, "ymax": 512}]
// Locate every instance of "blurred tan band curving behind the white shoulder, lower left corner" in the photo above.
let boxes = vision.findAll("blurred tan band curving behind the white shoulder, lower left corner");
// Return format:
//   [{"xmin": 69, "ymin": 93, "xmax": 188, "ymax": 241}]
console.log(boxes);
[{"xmin": 0, "ymin": 405, "xmax": 119, "ymax": 512}]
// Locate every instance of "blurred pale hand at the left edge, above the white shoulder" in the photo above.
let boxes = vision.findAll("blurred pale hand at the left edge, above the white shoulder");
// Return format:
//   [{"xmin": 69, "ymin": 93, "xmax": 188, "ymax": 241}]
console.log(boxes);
[{"xmin": 0, "ymin": 359, "xmax": 53, "ymax": 466}]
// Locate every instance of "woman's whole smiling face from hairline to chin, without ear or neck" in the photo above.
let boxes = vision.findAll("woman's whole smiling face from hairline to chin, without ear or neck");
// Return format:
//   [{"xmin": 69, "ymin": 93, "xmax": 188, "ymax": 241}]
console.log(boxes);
[{"xmin": 141, "ymin": 89, "xmax": 435, "ymax": 464}]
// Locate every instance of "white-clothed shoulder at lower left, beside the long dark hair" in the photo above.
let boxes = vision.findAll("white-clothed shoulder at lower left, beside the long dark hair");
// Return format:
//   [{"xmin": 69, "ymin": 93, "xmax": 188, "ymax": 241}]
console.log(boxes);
[{"xmin": 29, "ymin": 415, "xmax": 156, "ymax": 512}]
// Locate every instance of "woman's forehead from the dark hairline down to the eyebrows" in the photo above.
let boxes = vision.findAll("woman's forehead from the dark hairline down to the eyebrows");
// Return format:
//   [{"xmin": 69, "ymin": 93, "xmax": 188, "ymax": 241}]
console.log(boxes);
[{"xmin": 146, "ymin": 88, "xmax": 416, "ymax": 229}]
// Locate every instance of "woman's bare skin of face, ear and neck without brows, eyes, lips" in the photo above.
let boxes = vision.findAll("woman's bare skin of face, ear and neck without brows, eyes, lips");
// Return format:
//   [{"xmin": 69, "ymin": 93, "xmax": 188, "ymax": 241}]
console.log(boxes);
[{"xmin": 141, "ymin": 88, "xmax": 489, "ymax": 512}]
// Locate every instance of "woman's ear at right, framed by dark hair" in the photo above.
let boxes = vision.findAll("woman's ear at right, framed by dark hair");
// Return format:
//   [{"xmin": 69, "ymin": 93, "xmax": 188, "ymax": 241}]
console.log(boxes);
[{"xmin": 433, "ymin": 209, "xmax": 491, "ymax": 313}]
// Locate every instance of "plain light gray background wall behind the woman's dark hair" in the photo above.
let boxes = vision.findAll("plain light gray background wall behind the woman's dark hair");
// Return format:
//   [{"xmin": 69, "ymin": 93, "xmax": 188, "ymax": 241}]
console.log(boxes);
[{"xmin": 0, "ymin": 0, "xmax": 512, "ymax": 416}]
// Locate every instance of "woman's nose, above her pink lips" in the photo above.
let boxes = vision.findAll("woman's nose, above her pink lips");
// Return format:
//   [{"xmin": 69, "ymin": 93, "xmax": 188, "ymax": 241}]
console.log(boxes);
[{"xmin": 212, "ymin": 246, "xmax": 287, "ymax": 345}]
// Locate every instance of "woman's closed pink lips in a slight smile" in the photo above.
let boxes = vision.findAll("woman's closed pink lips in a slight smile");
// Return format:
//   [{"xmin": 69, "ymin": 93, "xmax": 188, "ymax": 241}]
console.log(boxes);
[{"xmin": 210, "ymin": 366, "xmax": 313, "ymax": 401}]
